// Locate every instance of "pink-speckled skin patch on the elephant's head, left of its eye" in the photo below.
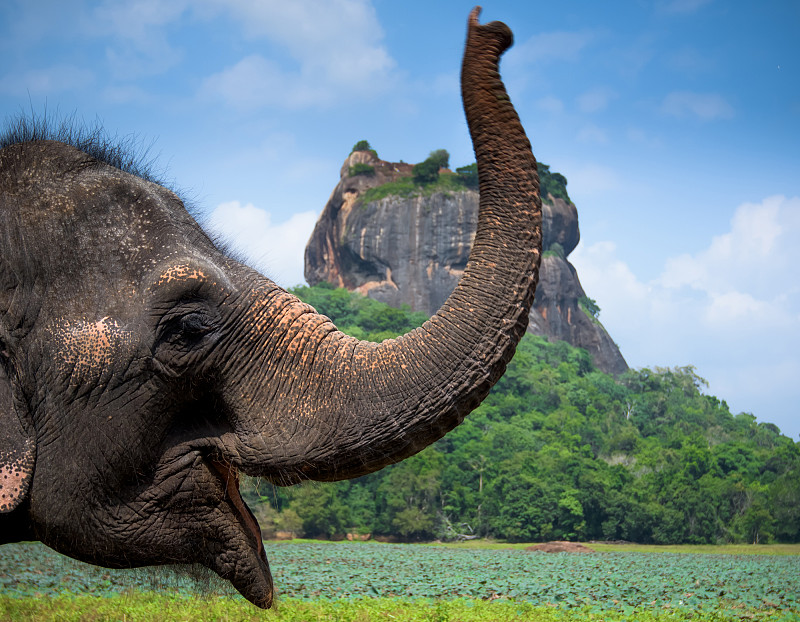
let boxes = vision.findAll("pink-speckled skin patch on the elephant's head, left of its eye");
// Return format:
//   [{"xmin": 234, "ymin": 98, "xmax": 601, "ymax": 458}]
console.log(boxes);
[{"xmin": 50, "ymin": 317, "xmax": 135, "ymax": 383}]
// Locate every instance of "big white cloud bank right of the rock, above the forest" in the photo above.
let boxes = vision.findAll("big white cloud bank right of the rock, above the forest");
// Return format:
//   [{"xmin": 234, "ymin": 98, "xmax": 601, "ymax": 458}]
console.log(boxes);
[{"xmin": 570, "ymin": 196, "xmax": 800, "ymax": 436}]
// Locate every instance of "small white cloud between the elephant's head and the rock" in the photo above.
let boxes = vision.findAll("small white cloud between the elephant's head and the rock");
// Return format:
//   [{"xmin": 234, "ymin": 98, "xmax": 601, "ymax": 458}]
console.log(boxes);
[{"xmin": 206, "ymin": 201, "xmax": 317, "ymax": 287}]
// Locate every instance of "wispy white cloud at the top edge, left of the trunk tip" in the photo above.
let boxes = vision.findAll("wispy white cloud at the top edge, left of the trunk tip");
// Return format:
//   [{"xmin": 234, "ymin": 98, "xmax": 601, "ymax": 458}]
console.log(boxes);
[{"xmin": 202, "ymin": 0, "xmax": 395, "ymax": 108}]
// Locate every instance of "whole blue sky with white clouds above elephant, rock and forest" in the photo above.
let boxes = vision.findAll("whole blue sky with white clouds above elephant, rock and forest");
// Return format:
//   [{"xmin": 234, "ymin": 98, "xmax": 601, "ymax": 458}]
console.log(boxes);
[{"xmin": 0, "ymin": 0, "xmax": 800, "ymax": 440}]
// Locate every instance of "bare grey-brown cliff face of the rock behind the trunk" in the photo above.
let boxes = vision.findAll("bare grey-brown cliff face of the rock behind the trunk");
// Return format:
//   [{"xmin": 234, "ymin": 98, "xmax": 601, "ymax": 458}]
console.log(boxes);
[{"xmin": 305, "ymin": 151, "xmax": 628, "ymax": 374}]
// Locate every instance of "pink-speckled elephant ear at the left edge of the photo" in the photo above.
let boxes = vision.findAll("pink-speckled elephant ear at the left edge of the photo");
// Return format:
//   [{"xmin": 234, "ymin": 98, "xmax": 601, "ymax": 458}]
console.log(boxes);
[{"xmin": 0, "ymin": 365, "xmax": 36, "ymax": 513}]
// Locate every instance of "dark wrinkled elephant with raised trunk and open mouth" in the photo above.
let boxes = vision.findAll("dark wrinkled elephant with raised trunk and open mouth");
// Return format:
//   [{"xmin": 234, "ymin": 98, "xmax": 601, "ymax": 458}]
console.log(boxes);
[{"xmin": 0, "ymin": 7, "xmax": 542, "ymax": 608}]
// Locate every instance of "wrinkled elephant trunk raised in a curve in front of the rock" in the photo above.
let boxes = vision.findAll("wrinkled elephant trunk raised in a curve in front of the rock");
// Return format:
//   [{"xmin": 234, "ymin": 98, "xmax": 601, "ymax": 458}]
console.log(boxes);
[{"xmin": 237, "ymin": 9, "xmax": 542, "ymax": 483}]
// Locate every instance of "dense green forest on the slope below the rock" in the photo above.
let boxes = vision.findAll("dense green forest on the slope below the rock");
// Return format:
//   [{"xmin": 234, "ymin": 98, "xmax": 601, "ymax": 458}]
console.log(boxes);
[{"xmin": 242, "ymin": 285, "xmax": 800, "ymax": 544}]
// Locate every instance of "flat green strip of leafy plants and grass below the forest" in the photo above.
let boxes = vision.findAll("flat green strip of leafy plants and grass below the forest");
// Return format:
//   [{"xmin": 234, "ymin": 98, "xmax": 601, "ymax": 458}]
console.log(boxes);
[{"xmin": 0, "ymin": 541, "xmax": 800, "ymax": 622}]
